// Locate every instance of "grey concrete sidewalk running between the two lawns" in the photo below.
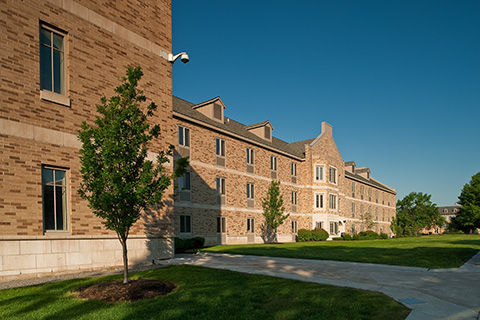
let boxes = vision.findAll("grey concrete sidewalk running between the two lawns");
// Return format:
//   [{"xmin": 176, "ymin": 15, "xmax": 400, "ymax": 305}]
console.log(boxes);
[{"xmin": 170, "ymin": 252, "xmax": 480, "ymax": 320}]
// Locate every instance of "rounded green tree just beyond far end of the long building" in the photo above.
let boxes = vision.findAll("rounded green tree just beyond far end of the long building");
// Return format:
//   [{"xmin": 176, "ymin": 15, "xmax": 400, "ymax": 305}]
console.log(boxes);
[{"xmin": 390, "ymin": 192, "xmax": 445, "ymax": 236}]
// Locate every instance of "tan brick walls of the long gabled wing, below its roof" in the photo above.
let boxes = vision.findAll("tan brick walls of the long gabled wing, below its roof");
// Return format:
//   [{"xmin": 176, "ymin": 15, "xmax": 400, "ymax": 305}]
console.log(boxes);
[{"xmin": 175, "ymin": 116, "xmax": 395, "ymax": 244}]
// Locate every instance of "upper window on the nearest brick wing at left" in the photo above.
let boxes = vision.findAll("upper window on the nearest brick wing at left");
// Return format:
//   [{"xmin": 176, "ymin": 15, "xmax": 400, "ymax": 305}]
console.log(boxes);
[{"xmin": 40, "ymin": 24, "xmax": 66, "ymax": 95}]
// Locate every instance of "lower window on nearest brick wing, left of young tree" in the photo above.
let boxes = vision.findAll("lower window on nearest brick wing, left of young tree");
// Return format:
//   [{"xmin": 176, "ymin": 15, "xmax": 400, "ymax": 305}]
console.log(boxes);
[{"xmin": 42, "ymin": 167, "xmax": 67, "ymax": 231}]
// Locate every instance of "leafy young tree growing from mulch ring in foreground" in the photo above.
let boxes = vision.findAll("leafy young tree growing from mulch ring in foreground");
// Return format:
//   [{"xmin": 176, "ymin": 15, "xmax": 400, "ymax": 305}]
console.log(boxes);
[{"xmin": 78, "ymin": 67, "xmax": 188, "ymax": 283}]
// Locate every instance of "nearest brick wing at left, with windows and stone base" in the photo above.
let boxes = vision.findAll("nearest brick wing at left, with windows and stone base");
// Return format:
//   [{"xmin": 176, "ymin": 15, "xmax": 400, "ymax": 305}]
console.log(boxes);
[{"xmin": 0, "ymin": 0, "xmax": 176, "ymax": 280}]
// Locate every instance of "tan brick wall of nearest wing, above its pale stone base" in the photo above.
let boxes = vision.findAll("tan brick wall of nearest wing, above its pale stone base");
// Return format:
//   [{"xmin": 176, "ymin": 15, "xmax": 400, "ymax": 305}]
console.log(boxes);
[{"xmin": 0, "ymin": 0, "xmax": 176, "ymax": 278}]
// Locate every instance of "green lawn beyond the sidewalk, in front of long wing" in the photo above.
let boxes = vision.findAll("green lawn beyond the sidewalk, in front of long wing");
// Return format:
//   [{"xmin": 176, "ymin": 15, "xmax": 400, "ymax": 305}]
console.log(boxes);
[{"xmin": 202, "ymin": 234, "xmax": 480, "ymax": 268}]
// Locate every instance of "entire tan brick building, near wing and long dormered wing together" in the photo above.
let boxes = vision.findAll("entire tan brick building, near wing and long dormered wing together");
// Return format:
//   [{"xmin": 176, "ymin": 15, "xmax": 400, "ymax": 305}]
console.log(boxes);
[{"xmin": 0, "ymin": 0, "xmax": 395, "ymax": 280}]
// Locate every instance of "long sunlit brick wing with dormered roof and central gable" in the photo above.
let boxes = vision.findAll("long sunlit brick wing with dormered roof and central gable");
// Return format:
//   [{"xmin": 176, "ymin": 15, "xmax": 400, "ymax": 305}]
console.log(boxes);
[{"xmin": 173, "ymin": 97, "xmax": 396, "ymax": 245}]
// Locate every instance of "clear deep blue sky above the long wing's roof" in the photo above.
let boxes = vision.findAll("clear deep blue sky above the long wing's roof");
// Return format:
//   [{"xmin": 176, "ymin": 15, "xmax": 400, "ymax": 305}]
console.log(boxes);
[{"xmin": 172, "ymin": 0, "xmax": 480, "ymax": 206}]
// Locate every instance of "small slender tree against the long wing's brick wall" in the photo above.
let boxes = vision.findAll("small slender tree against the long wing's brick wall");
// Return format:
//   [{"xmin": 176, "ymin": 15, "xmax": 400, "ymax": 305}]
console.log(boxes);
[{"xmin": 262, "ymin": 180, "xmax": 289, "ymax": 242}]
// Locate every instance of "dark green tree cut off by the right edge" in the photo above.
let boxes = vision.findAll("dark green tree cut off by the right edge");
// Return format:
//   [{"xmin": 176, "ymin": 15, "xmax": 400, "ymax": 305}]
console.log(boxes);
[{"xmin": 455, "ymin": 172, "xmax": 480, "ymax": 233}]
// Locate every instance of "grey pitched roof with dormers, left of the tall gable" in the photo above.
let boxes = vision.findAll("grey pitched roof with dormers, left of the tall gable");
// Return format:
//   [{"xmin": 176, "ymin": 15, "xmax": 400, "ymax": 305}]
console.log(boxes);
[{"xmin": 173, "ymin": 96, "xmax": 313, "ymax": 160}]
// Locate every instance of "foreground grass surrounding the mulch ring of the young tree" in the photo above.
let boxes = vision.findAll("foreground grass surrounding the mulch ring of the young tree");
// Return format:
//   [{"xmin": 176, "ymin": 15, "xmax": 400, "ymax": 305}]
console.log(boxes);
[{"xmin": 0, "ymin": 265, "xmax": 410, "ymax": 320}]
